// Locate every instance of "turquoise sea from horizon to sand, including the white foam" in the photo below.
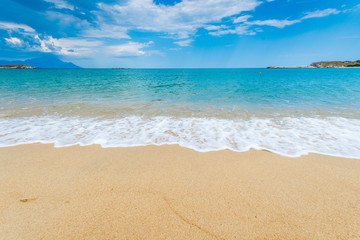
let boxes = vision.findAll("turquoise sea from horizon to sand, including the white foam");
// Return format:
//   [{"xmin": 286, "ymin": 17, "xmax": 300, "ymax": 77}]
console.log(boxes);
[{"xmin": 0, "ymin": 69, "xmax": 360, "ymax": 159}]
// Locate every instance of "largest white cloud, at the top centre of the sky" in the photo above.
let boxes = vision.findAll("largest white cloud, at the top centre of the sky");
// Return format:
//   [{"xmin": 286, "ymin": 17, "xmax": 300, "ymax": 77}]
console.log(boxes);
[{"xmin": 96, "ymin": 0, "xmax": 261, "ymax": 39}]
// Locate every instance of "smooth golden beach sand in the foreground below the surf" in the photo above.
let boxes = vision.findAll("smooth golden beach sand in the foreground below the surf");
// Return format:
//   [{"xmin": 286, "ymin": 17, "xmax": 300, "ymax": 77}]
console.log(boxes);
[{"xmin": 0, "ymin": 144, "xmax": 360, "ymax": 240}]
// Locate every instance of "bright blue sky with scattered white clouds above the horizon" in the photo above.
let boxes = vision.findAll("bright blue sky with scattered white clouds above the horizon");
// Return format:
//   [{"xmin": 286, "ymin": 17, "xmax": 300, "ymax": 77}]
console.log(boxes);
[{"xmin": 0, "ymin": 0, "xmax": 360, "ymax": 68}]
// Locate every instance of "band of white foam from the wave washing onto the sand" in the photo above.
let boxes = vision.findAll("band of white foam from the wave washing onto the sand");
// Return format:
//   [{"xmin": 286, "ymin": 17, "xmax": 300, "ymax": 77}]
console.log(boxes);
[{"xmin": 0, "ymin": 116, "xmax": 360, "ymax": 159}]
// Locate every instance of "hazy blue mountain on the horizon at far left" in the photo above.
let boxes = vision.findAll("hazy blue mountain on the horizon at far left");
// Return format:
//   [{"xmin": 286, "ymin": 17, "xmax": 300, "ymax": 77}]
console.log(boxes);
[{"xmin": 0, "ymin": 55, "xmax": 81, "ymax": 68}]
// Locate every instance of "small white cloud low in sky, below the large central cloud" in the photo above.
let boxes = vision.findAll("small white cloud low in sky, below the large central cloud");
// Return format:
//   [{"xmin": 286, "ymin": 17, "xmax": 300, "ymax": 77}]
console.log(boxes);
[{"xmin": 106, "ymin": 41, "xmax": 154, "ymax": 57}]
